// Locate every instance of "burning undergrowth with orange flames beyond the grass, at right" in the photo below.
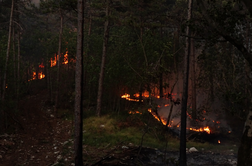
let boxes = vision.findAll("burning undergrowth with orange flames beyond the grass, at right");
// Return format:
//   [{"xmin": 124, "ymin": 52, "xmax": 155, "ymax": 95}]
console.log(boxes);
[{"xmin": 121, "ymin": 92, "xmax": 232, "ymax": 143}]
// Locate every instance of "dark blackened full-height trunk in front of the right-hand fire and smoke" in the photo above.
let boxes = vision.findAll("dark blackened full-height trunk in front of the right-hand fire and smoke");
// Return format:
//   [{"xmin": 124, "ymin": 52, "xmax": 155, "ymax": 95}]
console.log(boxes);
[{"xmin": 179, "ymin": 0, "xmax": 193, "ymax": 166}]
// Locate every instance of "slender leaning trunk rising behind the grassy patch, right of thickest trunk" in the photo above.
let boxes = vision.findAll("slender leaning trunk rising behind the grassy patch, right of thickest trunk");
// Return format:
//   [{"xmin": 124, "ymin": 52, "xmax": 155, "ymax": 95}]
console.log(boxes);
[{"xmin": 96, "ymin": 0, "xmax": 110, "ymax": 117}]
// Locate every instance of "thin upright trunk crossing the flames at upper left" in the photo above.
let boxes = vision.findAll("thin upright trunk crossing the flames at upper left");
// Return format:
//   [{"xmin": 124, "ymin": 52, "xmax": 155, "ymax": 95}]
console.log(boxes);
[{"xmin": 55, "ymin": 8, "xmax": 63, "ymax": 110}]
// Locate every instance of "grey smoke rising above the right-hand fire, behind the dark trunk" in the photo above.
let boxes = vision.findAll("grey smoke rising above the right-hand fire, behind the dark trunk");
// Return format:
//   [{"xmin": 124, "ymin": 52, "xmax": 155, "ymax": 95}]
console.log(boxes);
[{"xmin": 150, "ymin": 71, "xmax": 232, "ymax": 133}]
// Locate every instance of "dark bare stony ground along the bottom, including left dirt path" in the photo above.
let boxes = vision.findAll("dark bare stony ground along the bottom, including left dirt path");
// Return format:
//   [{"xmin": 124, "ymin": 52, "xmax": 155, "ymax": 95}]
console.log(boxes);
[{"xmin": 0, "ymin": 92, "xmax": 237, "ymax": 166}]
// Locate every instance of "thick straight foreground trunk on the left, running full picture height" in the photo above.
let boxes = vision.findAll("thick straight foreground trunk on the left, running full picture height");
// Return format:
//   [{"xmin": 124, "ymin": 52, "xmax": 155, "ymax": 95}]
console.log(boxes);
[{"xmin": 74, "ymin": 0, "xmax": 84, "ymax": 166}]
